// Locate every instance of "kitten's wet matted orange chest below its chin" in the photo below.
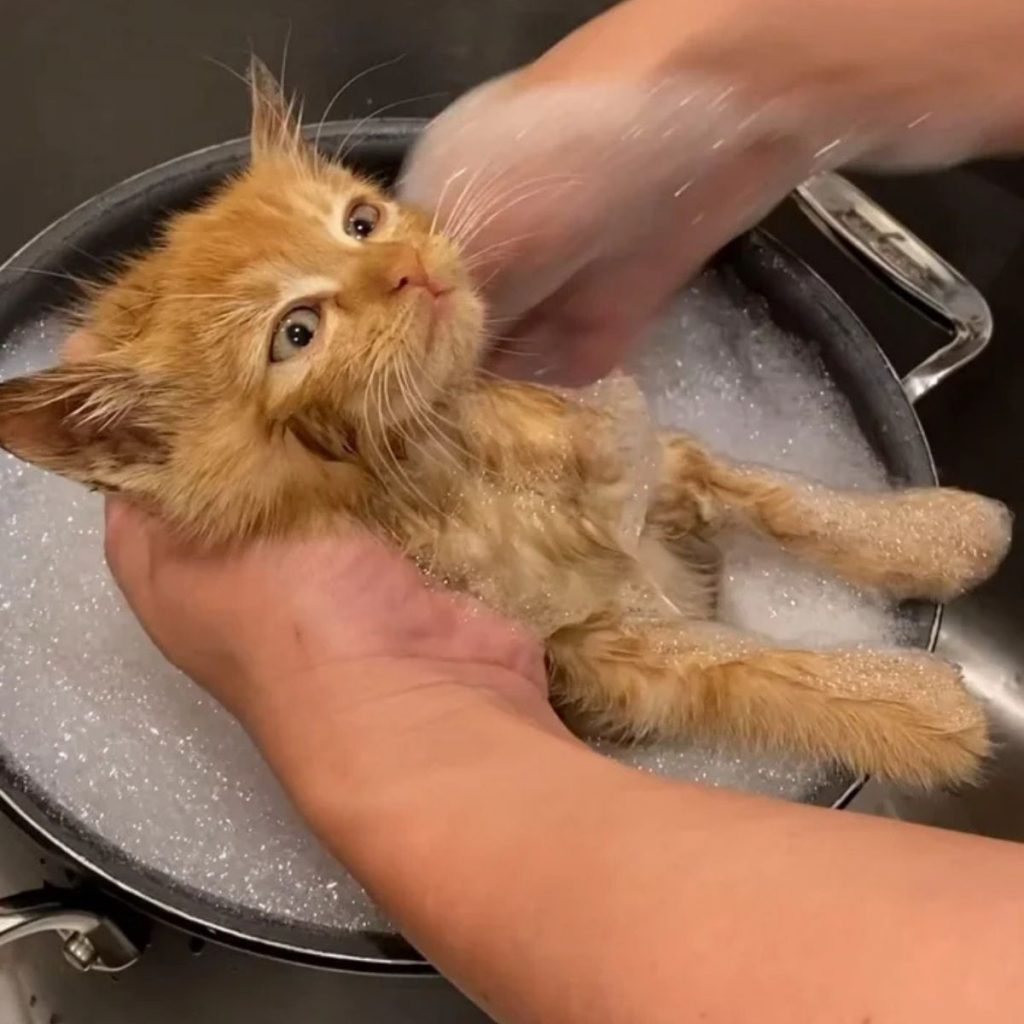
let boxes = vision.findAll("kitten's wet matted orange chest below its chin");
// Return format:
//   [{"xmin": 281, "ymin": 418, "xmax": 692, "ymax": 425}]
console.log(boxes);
[{"xmin": 387, "ymin": 372, "xmax": 660, "ymax": 635}]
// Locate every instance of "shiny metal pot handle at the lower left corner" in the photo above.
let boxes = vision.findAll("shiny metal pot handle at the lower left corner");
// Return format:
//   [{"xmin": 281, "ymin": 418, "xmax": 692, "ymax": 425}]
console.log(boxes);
[{"xmin": 0, "ymin": 886, "xmax": 142, "ymax": 974}]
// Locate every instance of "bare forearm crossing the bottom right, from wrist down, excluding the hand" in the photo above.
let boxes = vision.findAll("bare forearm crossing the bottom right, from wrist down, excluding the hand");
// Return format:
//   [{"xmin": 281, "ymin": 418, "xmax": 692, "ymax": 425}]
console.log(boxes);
[{"xmin": 274, "ymin": 659, "xmax": 1024, "ymax": 1024}]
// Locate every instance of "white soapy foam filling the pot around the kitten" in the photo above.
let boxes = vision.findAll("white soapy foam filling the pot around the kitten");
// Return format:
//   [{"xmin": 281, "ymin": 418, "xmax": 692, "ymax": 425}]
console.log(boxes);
[{"xmin": 0, "ymin": 279, "xmax": 913, "ymax": 930}]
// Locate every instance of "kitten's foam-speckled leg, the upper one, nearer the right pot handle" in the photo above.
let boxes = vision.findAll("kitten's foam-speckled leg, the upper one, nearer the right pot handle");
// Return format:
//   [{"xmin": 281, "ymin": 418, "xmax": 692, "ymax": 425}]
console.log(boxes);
[{"xmin": 648, "ymin": 435, "xmax": 1012, "ymax": 601}]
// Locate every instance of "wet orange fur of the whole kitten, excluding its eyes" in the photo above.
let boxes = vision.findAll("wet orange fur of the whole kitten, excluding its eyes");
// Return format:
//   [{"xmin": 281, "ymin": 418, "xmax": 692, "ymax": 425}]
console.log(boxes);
[{"xmin": 0, "ymin": 66, "xmax": 1009, "ymax": 785}]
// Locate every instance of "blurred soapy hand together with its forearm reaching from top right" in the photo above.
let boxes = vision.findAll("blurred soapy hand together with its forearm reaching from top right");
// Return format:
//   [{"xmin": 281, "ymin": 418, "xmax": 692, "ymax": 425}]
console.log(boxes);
[{"xmin": 400, "ymin": 0, "xmax": 1024, "ymax": 384}]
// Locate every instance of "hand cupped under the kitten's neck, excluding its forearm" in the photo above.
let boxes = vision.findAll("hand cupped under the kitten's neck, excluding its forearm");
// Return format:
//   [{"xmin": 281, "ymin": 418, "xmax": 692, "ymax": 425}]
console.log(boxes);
[{"xmin": 106, "ymin": 499, "xmax": 557, "ymax": 796}]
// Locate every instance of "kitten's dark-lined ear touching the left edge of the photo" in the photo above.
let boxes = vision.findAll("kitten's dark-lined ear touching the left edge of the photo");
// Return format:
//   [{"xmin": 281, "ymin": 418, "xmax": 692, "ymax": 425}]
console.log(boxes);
[{"xmin": 0, "ymin": 359, "xmax": 170, "ymax": 490}]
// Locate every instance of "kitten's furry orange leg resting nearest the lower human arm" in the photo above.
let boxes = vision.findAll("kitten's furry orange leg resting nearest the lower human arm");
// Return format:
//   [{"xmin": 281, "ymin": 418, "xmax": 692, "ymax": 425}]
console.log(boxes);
[{"xmin": 548, "ymin": 614, "xmax": 988, "ymax": 786}]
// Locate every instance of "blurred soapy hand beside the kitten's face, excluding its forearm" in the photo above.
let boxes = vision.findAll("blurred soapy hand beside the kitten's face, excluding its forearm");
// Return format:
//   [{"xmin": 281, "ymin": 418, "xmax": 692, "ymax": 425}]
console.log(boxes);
[{"xmin": 401, "ymin": 62, "xmax": 806, "ymax": 386}]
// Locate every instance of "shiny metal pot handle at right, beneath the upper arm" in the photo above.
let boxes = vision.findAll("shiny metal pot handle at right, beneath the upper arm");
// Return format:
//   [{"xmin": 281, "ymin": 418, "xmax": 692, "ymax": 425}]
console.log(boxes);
[{"xmin": 796, "ymin": 173, "xmax": 992, "ymax": 402}]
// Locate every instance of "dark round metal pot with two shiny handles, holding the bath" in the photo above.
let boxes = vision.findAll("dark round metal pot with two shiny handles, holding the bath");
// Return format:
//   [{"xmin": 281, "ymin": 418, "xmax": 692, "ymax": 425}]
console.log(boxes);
[{"xmin": 0, "ymin": 121, "xmax": 991, "ymax": 974}]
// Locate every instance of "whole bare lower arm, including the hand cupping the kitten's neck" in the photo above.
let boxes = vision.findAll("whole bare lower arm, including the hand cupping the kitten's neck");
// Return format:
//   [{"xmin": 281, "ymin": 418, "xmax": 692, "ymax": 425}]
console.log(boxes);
[{"xmin": 99, "ymin": 506, "xmax": 1024, "ymax": 1024}]
